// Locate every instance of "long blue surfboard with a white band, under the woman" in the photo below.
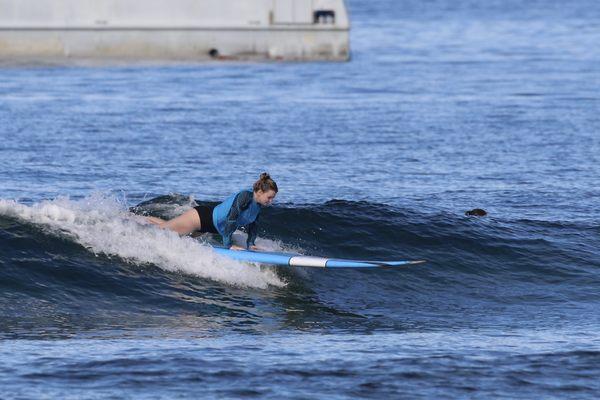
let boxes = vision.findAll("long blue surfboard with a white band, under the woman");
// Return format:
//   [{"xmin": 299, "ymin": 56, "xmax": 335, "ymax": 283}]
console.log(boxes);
[{"xmin": 213, "ymin": 247, "xmax": 425, "ymax": 268}]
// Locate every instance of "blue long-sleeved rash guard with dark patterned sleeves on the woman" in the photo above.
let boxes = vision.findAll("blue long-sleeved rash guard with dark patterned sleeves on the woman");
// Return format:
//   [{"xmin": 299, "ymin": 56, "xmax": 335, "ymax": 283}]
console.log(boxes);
[{"xmin": 213, "ymin": 190, "xmax": 261, "ymax": 248}]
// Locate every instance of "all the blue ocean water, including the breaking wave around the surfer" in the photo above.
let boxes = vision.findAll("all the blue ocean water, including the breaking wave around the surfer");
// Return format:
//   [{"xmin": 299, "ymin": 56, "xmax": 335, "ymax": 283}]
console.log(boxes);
[{"xmin": 0, "ymin": 0, "xmax": 600, "ymax": 399}]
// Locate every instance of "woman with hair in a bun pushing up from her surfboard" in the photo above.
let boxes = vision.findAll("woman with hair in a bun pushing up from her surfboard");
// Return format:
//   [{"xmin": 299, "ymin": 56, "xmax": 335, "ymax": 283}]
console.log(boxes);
[{"xmin": 147, "ymin": 172, "xmax": 278, "ymax": 250}]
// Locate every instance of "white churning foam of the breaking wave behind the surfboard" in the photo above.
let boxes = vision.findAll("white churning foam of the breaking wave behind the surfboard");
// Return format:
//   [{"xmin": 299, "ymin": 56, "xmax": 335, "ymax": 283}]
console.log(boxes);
[{"xmin": 0, "ymin": 194, "xmax": 285, "ymax": 288}]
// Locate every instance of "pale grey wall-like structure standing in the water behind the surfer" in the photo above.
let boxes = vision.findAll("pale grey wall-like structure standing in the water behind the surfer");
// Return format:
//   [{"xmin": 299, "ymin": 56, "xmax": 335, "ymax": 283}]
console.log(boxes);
[{"xmin": 0, "ymin": 0, "xmax": 350, "ymax": 62}]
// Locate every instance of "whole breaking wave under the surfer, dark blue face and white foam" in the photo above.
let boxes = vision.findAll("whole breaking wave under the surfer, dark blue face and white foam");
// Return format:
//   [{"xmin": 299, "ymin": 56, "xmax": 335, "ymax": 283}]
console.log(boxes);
[{"xmin": 0, "ymin": 194, "xmax": 600, "ymax": 332}]
